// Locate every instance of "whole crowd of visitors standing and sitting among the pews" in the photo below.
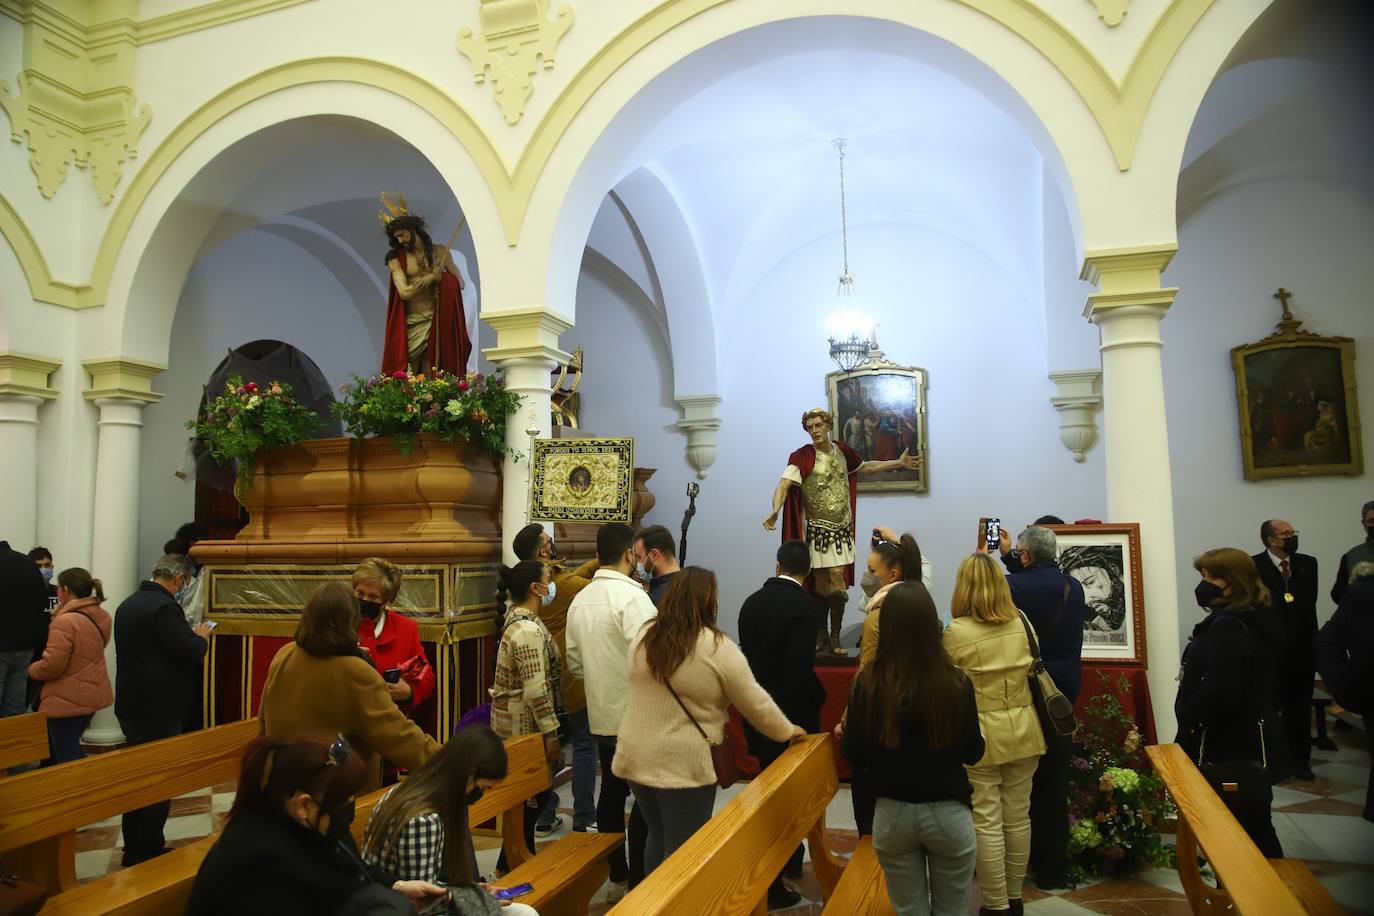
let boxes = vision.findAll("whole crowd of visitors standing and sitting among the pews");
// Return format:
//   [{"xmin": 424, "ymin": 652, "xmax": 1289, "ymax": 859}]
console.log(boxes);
[{"xmin": 0, "ymin": 503, "xmax": 1374, "ymax": 916}]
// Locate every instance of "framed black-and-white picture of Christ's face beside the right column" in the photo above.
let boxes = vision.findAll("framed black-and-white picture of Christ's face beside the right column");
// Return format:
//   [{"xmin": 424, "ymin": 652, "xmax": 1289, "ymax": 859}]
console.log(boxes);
[{"xmin": 1050, "ymin": 523, "xmax": 1145, "ymax": 665}]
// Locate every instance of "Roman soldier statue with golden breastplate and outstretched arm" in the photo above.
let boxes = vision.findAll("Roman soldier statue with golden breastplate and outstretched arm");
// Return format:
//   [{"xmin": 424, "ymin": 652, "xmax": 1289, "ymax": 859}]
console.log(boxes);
[{"xmin": 764, "ymin": 407, "xmax": 921, "ymax": 655}]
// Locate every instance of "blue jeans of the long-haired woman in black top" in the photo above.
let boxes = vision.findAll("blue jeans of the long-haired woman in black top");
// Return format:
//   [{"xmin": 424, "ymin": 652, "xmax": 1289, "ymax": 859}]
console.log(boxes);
[{"xmin": 872, "ymin": 798, "xmax": 978, "ymax": 916}]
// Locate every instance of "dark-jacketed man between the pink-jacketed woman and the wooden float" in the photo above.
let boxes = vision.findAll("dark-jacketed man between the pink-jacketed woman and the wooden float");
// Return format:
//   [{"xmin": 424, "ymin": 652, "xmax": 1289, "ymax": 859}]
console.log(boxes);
[{"xmin": 114, "ymin": 553, "xmax": 210, "ymax": 868}]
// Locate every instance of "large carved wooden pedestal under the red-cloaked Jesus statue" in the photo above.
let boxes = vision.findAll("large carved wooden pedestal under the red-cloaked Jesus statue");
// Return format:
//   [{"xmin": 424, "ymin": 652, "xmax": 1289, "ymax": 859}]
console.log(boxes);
[{"xmin": 191, "ymin": 435, "xmax": 654, "ymax": 739}]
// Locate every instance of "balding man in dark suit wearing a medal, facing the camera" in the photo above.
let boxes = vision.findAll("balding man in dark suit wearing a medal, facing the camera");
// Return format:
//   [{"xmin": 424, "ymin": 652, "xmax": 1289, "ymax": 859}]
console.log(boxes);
[{"xmin": 1253, "ymin": 519, "xmax": 1316, "ymax": 780}]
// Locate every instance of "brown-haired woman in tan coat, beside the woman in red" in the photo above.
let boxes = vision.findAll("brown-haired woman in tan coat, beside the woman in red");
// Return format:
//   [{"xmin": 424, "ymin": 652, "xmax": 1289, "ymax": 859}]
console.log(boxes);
[{"xmin": 258, "ymin": 582, "xmax": 438, "ymax": 792}]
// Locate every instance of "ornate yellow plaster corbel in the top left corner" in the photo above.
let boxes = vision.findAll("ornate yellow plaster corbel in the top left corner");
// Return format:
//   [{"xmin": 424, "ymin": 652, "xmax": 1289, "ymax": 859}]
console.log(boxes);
[{"xmin": 0, "ymin": 0, "xmax": 153, "ymax": 203}]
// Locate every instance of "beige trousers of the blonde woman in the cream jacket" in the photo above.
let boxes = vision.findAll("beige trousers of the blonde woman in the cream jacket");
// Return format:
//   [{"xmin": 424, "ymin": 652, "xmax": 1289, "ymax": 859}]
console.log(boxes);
[{"xmin": 965, "ymin": 755, "xmax": 1040, "ymax": 909}]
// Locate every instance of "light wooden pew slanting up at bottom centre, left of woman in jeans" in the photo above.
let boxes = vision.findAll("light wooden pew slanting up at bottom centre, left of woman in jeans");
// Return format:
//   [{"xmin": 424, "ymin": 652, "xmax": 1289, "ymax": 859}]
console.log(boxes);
[{"xmin": 607, "ymin": 735, "xmax": 845, "ymax": 916}]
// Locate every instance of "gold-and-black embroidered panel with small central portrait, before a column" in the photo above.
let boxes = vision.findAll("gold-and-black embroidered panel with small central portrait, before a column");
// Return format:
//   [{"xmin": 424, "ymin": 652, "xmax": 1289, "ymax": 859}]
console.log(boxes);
[{"xmin": 529, "ymin": 438, "xmax": 635, "ymax": 523}]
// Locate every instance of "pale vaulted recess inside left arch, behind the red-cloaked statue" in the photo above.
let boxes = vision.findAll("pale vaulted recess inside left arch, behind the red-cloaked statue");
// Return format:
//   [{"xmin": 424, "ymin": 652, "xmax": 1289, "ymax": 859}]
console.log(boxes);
[{"xmin": 129, "ymin": 115, "xmax": 491, "ymax": 566}]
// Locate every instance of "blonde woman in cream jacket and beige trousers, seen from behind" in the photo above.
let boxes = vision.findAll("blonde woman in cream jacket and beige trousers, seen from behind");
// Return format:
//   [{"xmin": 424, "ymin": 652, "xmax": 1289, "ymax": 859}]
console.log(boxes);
[{"xmin": 944, "ymin": 553, "xmax": 1044, "ymax": 915}]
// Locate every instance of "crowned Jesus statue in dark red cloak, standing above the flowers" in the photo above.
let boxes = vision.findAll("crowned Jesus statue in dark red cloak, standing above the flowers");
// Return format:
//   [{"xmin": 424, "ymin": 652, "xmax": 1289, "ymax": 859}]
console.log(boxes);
[{"xmin": 378, "ymin": 194, "xmax": 473, "ymax": 375}]
